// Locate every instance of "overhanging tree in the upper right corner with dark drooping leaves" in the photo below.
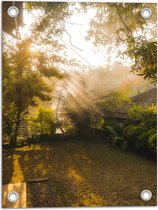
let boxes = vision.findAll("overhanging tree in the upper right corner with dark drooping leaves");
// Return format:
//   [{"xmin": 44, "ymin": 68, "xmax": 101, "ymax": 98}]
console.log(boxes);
[{"xmin": 82, "ymin": 3, "xmax": 157, "ymax": 82}]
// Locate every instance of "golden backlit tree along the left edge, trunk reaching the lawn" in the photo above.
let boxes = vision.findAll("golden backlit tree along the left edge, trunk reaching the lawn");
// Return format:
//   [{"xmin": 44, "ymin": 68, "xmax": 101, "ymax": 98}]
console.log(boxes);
[{"xmin": 2, "ymin": 39, "xmax": 61, "ymax": 144}]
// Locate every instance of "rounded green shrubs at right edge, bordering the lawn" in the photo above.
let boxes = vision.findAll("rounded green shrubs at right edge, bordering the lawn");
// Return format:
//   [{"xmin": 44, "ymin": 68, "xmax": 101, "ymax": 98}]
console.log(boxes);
[{"xmin": 124, "ymin": 105, "xmax": 157, "ymax": 154}]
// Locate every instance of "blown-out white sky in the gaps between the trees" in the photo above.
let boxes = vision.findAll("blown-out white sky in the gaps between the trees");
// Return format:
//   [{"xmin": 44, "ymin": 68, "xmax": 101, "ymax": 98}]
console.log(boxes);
[{"xmin": 20, "ymin": 5, "xmax": 127, "ymax": 67}]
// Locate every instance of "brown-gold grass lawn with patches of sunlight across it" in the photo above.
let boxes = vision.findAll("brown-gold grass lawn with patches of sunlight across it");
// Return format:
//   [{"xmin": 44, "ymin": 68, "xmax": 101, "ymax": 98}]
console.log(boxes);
[{"xmin": 3, "ymin": 139, "xmax": 156, "ymax": 206}]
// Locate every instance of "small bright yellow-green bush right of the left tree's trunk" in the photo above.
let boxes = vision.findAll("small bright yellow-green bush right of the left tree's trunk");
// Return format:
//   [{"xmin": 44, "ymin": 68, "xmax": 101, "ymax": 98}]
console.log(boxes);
[{"xmin": 28, "ymin": 107, "xmax": 56, "ymax": 135}]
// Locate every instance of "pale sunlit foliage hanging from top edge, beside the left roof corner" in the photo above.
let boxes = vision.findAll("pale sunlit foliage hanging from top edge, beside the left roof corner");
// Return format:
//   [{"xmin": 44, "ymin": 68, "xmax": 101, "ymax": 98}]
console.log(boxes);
[{"xmin": 24, "ymin": 2, "xmax": 72, "ymax": 53}]
